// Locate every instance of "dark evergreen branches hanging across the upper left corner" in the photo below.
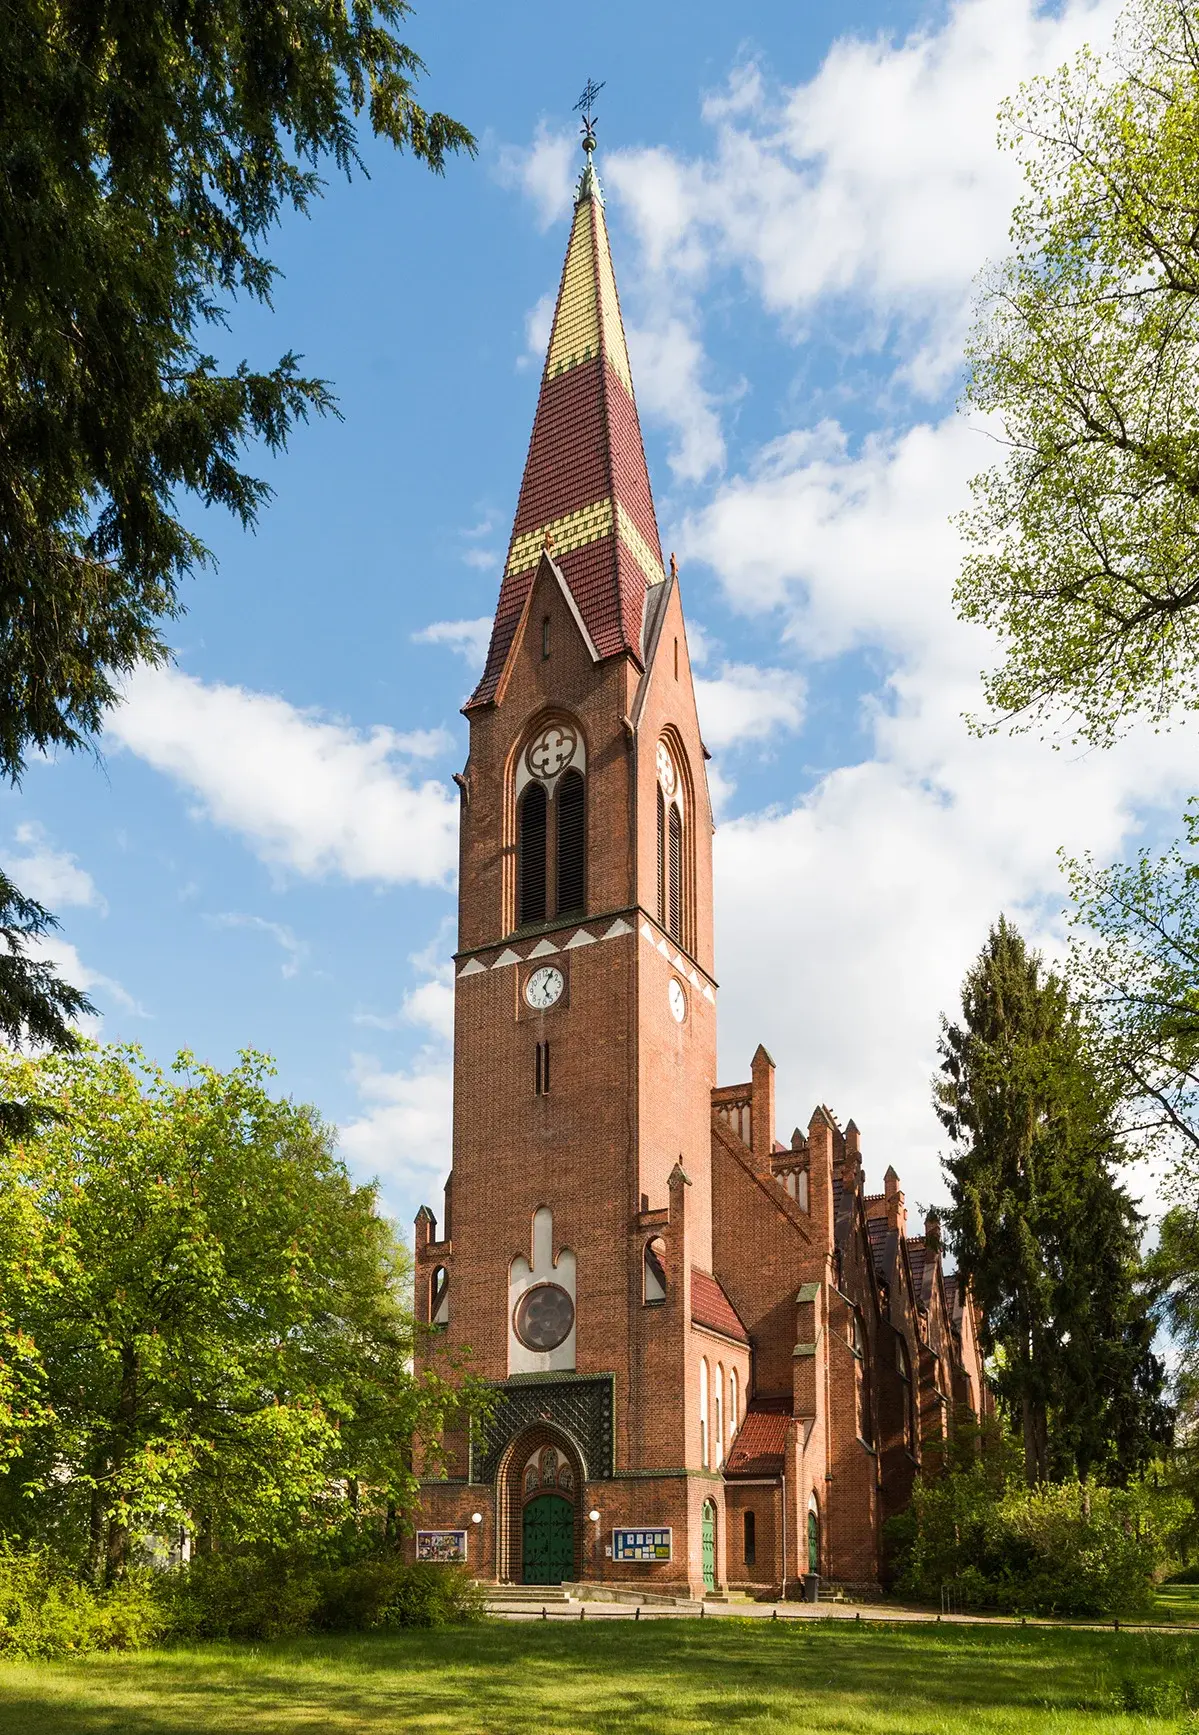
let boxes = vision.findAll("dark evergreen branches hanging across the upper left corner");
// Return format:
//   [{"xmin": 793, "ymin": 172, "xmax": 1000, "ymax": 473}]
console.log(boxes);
[{"xmin": 0, "ymin": 0, "xmax": 474, "ymax": 777}]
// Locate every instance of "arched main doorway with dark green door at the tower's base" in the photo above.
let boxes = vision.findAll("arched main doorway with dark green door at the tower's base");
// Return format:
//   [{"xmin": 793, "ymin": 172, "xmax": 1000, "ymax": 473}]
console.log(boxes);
[{"xmin": 496, "ymin": 1424, "xmax": 583, "ymax": 1584}]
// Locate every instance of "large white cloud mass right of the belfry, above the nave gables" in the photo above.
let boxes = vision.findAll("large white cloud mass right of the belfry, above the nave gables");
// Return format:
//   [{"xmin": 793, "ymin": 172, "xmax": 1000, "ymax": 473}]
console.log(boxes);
[{"xmin": 687, "ymin": 418, "xmax": 1194, "ymax": 1202}]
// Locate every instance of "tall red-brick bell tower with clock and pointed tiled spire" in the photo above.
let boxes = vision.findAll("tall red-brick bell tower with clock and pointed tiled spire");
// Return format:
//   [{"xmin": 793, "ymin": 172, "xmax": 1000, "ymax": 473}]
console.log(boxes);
[{"xmin": 416, "ymin": 125, "xmax": 748, "ymax": 1588}]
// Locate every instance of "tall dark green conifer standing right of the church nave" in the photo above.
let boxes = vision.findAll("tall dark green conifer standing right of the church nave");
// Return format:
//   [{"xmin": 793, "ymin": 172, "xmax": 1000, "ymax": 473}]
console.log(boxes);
[{"xmin": 934, "ymin": 918, "xmax": 1168, "ymax": 1483}]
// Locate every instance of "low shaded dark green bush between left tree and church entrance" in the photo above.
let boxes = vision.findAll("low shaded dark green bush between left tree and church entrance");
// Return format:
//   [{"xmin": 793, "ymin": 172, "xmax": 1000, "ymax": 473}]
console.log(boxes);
[{"xmin": 163, "ymin": 1549, "xmax": 482, "ymax": 1638}]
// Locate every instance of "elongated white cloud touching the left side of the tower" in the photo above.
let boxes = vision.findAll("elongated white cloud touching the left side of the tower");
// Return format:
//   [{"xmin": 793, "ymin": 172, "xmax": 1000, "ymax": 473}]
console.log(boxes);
[{"xmin": 108, "ymin": 668, "xmax": 458, "ymax": 885}]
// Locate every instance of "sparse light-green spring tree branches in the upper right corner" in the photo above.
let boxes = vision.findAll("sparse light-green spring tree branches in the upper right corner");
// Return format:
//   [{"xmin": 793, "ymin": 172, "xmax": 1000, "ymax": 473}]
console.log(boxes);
[{"xmin": 956, "ymin": 0, "xmax": 1199, "ymax": 743}]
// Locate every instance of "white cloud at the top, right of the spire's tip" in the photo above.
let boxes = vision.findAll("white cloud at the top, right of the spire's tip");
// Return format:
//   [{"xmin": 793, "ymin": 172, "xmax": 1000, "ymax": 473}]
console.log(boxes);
[{"xmin": 607, "ymin": 0, "xmax": 1121, "ymax": 396}]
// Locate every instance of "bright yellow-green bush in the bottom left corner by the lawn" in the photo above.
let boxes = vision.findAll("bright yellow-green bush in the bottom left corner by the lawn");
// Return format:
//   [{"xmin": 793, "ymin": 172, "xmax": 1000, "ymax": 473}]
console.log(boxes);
[{"xmin": 0, "ymin": 1542, "xmax": 167, "ymax": 1660}]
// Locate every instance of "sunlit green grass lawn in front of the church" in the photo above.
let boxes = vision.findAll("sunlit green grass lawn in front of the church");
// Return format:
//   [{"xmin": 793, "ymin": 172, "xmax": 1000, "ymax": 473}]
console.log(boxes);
[{"xmin": 0, "ymin": 1619, "xmax": 1199, "ymax": 1735}]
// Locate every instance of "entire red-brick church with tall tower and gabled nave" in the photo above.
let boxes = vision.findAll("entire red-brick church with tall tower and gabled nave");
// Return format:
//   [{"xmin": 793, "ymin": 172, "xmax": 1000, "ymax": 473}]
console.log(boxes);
[{"xmin": 407, "ymin": 134, "xmax": 986, "ymax": 1594}]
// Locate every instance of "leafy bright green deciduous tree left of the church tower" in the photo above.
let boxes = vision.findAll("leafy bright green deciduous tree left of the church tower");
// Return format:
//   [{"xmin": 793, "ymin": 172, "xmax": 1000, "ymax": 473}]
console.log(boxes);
[{"xmin": 0, "ymin": 1044, "xmax": 479, "ymax": 1582}]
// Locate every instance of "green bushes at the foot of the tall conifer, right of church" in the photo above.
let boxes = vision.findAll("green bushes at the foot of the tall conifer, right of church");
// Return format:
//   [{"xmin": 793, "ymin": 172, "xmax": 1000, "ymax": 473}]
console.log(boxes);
[{"xmin": 888, "ymin": 1468, "xmax": 1170, "ymax": 1617}]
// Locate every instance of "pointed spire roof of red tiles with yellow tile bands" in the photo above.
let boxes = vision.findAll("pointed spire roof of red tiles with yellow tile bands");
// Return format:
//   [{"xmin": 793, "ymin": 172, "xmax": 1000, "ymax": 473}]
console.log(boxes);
[{"xmin": 467, "ymin": 139, "xmax": 666, "ymax": 711}]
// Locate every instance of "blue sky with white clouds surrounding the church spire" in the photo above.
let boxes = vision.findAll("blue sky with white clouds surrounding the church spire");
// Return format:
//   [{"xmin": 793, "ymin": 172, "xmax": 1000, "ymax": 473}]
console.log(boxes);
[{"xmin": 14, "ymin": 0, "xmax": 1194, "ymax": 1227}]
